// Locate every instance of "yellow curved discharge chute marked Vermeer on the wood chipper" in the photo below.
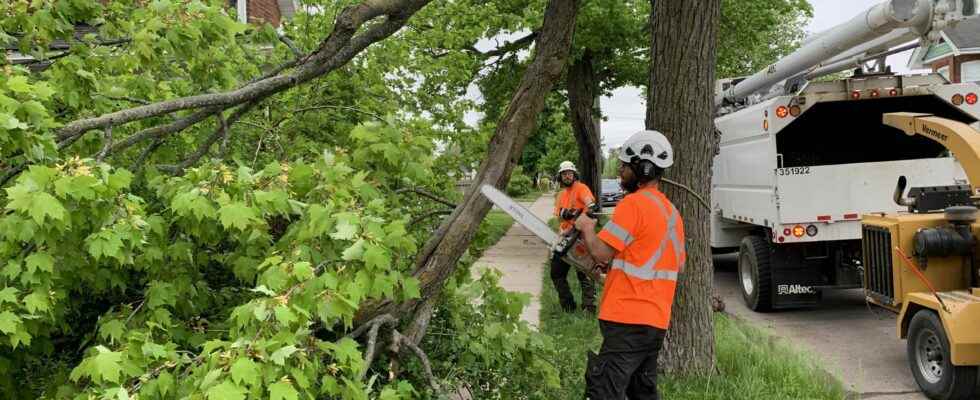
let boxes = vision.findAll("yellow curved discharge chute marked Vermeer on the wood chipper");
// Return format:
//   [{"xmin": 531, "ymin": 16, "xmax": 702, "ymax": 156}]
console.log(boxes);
[{"xmin": 883, "ymin": 113, "xmax": 980, "ymax": 197}]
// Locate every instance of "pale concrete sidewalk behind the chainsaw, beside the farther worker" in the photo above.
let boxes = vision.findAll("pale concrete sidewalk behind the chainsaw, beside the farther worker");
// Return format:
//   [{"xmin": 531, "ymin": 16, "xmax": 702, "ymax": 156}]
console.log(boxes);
[{"xmin": 471, "ymin": 194, "xmax": 554, "ymax": 327}]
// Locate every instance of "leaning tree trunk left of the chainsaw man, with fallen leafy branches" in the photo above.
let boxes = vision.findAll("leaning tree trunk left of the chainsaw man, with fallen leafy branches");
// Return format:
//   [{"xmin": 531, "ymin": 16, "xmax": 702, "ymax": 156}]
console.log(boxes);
[{"xmin": 356, "ymin": 0, "xmax": 579, "ymax": 326}]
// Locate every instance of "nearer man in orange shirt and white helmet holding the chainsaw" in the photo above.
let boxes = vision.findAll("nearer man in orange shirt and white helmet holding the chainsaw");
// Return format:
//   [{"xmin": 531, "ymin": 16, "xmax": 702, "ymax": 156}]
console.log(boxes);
[{"xmin": 575, "ymin": 131, "xmax": 687, "ymax": 400}]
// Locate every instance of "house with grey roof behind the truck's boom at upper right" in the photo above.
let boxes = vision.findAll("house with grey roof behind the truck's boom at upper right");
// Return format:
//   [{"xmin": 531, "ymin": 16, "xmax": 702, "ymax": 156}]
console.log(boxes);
[{"xmin": 908, "ymin": 18, "xmax": 980, "ymax": 83}]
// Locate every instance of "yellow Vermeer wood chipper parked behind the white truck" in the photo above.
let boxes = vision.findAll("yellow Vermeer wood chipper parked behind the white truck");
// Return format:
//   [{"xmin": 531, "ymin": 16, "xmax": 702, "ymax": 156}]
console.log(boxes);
[{"xmin": 861, "ymin": 113, "xmax": 980, "ymax": 400}]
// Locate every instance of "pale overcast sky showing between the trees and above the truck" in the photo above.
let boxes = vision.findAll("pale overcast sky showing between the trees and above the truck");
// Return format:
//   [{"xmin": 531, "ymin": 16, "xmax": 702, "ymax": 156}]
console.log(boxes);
[{"xmin": 600, "ymin": 0, "xmax": 928, "ymax": 149}]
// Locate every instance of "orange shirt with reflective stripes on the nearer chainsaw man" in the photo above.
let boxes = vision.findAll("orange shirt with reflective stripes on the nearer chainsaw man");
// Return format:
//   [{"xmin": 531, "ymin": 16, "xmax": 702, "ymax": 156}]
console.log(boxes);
[{"xmin": 599, "ymin": 188, "xmax": 687, "ymax": 329}]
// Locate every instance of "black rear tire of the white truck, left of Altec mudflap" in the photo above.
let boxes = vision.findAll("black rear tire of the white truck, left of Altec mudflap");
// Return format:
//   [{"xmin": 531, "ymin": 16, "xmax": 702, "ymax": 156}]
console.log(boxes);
[{"xmin": 738, "ymin": 236, "xmax": 772, "ymax": 311}]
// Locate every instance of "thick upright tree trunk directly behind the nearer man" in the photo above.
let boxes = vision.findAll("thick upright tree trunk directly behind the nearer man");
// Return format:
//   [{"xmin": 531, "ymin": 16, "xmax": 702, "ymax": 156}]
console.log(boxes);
[{"xmin": 646, "ymin": 0, "xmax": 721, "ymax": 374}]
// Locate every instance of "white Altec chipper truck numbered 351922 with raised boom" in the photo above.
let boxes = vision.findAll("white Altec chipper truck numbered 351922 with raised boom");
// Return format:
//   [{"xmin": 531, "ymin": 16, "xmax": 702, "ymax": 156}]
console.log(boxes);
[{"xmin": 711, "ymin": 0, "xmax": 980, "ymax": 311}]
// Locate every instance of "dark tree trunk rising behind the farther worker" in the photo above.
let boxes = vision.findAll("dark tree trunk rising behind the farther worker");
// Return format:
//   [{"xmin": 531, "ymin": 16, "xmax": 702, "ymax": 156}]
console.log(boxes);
[{"xmin": 566, "ymin": 49, "xmax": 603, "ymax": 199}]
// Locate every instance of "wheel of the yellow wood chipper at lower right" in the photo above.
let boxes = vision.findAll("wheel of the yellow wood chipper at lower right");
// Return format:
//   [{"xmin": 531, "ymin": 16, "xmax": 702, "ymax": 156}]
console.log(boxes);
[{"xmin": 906, "ymin": 310, "xmax": 977, "ymax": 400}]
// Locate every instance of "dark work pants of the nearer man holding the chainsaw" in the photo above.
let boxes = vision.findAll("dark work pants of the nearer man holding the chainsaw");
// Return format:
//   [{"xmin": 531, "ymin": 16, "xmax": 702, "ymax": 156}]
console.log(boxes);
[{"xmin": 585, "ymin": 320, "xmax": 667, "ymax": 400}]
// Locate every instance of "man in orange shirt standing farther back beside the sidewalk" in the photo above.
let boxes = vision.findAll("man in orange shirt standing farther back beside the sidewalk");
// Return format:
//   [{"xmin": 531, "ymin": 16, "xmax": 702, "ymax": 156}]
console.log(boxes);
[{"xmin": 551, "ymin": 161, "xmax": 595, "ymax": 313}]
